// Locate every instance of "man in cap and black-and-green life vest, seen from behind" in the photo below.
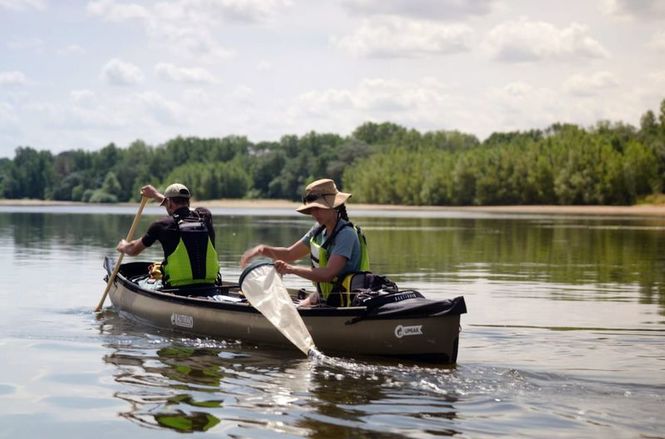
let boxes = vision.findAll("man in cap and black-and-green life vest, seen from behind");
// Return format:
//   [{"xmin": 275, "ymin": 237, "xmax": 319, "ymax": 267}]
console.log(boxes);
[{"xmin": 116, "ymin": 183, "xmax": 219, "ymax": 287}]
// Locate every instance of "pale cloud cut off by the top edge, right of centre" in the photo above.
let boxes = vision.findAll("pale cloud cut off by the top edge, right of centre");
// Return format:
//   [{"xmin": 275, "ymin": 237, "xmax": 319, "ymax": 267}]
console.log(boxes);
[{"xmin": 343, "ymin": 0, "xmax": 495, "ymax": 19}]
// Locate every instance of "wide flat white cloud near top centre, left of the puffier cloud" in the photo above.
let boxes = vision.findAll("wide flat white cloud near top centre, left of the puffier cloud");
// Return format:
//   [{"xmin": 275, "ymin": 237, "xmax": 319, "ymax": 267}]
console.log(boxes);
[{"xmin": 333, "ymin": 16, "xmax": 473, "ymax": 58}]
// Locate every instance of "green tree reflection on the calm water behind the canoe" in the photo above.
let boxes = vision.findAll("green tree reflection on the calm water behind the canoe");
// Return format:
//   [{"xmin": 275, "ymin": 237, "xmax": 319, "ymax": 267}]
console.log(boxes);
[{"xmin": 0, "ymin": 210, "xmax": 665, "ymax": 315}]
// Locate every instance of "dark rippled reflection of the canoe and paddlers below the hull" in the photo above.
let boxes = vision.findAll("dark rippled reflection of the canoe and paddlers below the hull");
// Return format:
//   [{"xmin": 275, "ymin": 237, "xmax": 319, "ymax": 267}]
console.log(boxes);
[{"xmin": 97, "ymin": 311, "xmax": 464, "ymax": 438}]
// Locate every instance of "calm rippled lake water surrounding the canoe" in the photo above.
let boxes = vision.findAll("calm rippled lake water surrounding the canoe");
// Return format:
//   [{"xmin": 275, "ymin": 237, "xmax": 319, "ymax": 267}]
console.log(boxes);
[{"xmin": 0, "ymin": 207, "xmax": 665, "ymax": 438}]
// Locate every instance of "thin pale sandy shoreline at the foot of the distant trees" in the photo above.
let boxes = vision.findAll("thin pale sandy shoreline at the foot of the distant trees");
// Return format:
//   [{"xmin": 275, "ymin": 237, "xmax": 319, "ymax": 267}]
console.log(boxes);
[{"xmin": 0, "ymin": 199, "xmax": 665, "ymax": 216}]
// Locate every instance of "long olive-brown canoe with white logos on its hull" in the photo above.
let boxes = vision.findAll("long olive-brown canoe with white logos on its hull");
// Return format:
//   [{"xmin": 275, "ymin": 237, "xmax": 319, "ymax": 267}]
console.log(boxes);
[{"xmin": 105, "ymin": 260, "xmax": 466, "ymax": 364}]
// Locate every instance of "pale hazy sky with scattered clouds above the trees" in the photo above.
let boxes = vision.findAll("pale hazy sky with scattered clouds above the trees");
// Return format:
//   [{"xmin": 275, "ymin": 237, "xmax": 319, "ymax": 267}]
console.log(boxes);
[{"xmin": 0, "ymin": 0, "xmax": 665, "ymax": 158}]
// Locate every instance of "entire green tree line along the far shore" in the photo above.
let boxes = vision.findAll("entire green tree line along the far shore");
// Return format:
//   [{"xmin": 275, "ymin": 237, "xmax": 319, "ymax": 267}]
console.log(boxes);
[{"xmin": 0, "ymin": 99, "xmax": 665, "ymax": 205}]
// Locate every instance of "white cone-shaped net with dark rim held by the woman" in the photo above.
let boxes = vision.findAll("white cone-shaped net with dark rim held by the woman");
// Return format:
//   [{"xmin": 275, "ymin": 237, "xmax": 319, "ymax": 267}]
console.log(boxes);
[{"xmin": 240, "ymin": 263, "xmax": 315, "ymax": 355}]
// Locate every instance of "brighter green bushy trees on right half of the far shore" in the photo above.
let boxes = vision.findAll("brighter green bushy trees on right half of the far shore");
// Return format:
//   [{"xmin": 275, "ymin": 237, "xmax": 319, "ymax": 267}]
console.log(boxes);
[{"xmin": 344, "ymin": 119, "xmax": 662, "ymax": 205}]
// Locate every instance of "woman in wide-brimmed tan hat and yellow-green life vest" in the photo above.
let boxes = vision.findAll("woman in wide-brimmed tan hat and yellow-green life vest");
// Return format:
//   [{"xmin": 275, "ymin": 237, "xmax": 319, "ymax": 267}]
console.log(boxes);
[{"xmin": 240, "ymin": 178, "xmax": 369, "ymax": 306}]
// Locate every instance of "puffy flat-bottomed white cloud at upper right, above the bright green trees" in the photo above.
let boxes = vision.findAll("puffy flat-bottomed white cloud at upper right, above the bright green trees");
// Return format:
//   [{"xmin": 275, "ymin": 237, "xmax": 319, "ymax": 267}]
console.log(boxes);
[{"xmin": 485, "ymin": 18, "xmax": 609, "ymax": 62}]
